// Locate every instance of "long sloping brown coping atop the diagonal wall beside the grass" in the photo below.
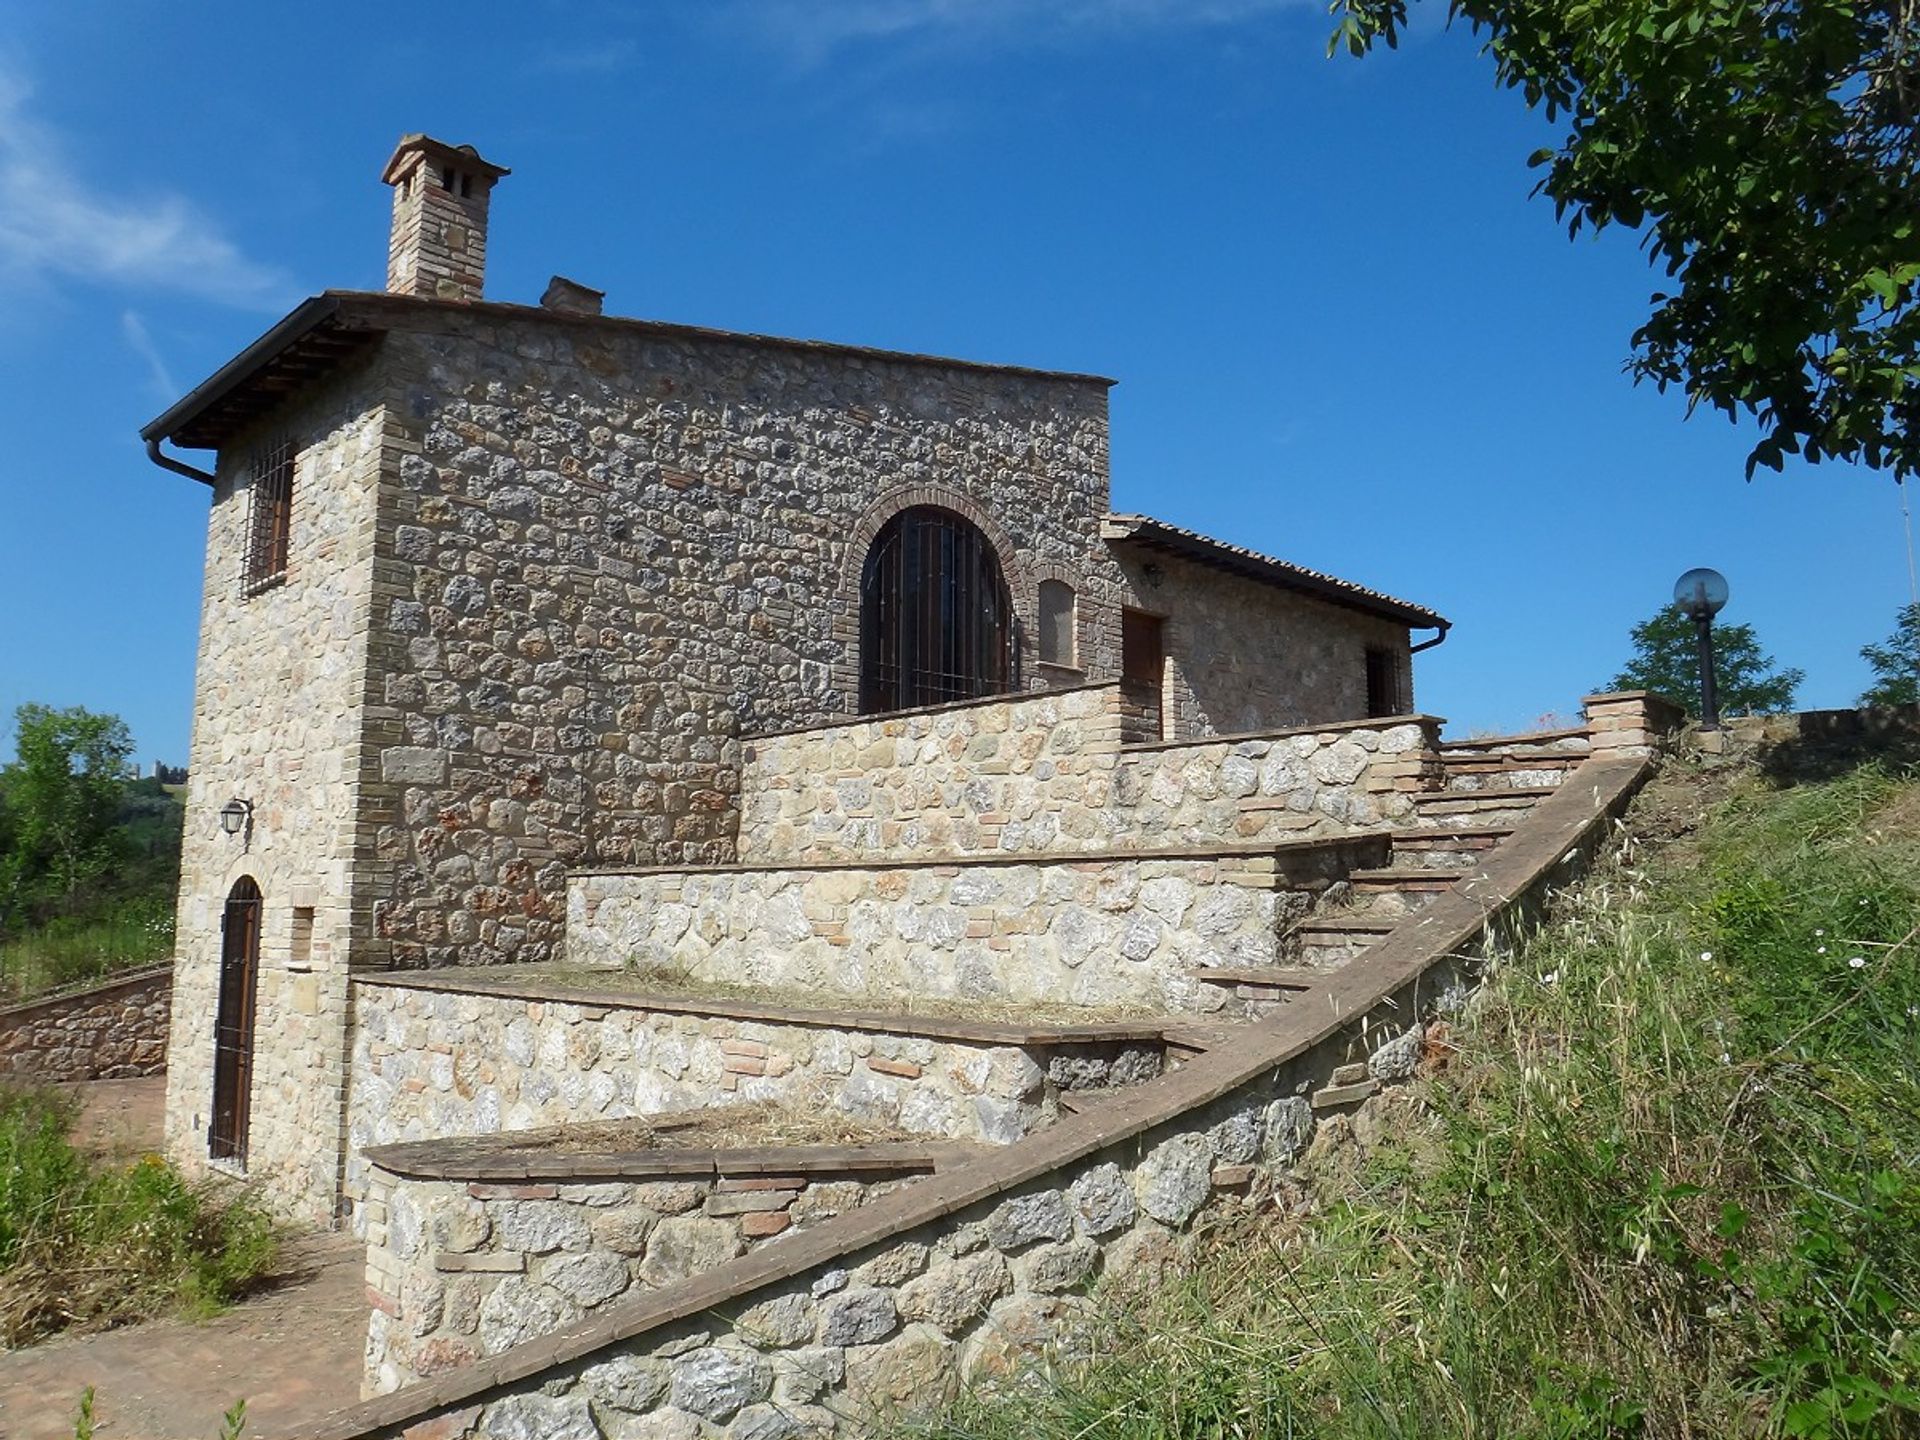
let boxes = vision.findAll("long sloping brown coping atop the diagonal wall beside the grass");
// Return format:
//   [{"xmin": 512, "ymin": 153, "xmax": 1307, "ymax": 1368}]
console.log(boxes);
[{"xmin": 296, "ymin": 755, "xmax": 1653, "ymax": 1440}]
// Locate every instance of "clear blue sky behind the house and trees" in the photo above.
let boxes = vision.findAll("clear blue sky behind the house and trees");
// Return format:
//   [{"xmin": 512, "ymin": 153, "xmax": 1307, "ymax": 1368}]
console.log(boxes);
[{"xmin": 0, "ymin": 0, "xmax": 1908, "ymax": 762}]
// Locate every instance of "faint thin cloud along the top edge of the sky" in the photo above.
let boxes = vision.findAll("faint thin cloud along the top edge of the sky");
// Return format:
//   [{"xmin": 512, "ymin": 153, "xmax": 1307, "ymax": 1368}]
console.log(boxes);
[{"xmin": 722, "ymin": 0, "xmax": 1317, "ymax": 63}]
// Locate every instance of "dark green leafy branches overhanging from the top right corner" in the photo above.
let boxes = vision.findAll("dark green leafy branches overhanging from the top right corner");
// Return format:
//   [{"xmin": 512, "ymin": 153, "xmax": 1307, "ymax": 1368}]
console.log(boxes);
[{"xmin": 1332, "ymin": 0, "xmax": 1920, "ymax": 478}]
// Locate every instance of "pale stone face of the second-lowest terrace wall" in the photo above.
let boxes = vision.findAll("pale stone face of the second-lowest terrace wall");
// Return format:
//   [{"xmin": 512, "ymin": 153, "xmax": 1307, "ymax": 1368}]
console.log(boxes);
[{"xmin": 348, "ymin": 979, "xmax": 1162, "ymax": 1196}]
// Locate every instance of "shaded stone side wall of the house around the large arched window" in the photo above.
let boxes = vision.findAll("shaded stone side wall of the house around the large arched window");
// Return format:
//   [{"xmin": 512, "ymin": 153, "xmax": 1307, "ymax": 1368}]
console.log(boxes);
[{"xmin": 369, "ymin": 309, "xmax": 1121, "ymax": 968}]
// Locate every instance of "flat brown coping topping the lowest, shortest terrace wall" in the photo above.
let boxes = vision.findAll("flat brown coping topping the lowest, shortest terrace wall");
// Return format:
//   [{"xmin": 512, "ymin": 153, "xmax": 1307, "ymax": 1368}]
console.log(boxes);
[{"xmin": 361, "ymin": 1133, "xmax": 996, "ymax": 1185}]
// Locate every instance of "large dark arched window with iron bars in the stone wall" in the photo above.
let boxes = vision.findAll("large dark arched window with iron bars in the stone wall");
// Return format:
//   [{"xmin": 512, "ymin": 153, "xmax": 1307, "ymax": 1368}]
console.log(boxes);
[{"xmin": 860, "ymin": 505, "xmax": 1014, "ymax": 712}]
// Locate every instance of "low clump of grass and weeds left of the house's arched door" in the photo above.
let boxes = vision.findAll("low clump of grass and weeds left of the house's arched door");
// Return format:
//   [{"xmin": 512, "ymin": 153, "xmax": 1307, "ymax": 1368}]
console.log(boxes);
[{"xmin": 0, "ymin": 1087, "xmax": 275, "ymax": 1348}]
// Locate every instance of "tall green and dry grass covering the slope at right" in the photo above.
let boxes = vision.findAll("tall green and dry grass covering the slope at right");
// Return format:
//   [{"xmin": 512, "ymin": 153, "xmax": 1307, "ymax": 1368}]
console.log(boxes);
[{"xmin": 913, "ymin": 770, "xmax": 1920, "ymax": 1440}]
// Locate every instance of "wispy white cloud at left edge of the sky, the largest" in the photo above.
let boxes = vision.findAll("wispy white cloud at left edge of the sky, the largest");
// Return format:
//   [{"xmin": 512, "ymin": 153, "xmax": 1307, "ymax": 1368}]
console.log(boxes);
[{"xmin": 0, "ymin": 60, "xmax": 292, "ymax": 309}]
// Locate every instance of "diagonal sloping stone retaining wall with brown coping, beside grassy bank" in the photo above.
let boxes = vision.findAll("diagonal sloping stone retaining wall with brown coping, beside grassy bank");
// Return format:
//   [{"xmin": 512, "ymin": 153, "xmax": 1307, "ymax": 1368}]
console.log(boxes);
[{"xmin": 284, "ymin": 758, "xmax": 1651, "ymax": 1440}]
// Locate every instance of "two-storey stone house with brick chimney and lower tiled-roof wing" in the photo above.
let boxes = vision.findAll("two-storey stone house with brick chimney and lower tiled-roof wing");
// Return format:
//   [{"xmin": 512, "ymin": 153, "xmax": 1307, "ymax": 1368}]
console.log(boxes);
[{"xmin": 142, "ymin": 134, "xmax": 1446, "ymax": 1217}]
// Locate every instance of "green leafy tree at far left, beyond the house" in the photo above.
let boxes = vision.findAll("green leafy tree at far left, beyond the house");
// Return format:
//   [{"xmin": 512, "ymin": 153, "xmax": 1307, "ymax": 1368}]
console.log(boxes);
[{"xmin": 0, "ymin": 705, "xmax": 132, "ymax": 925}]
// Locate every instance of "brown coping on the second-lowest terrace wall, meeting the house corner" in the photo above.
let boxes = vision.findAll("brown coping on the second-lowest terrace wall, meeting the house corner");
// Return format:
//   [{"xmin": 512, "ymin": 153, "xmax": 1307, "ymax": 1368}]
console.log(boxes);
[{"xmin": 353, "ymin": 966, "xmax": 1171, "ymax": 1044}]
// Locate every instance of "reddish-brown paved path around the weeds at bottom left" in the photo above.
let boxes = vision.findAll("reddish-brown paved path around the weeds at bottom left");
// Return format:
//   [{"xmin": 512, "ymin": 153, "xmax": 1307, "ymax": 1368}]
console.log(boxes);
[{"xmin": 0, "ymin": 1081, "xmax": 367, "ymax": 1440}]
